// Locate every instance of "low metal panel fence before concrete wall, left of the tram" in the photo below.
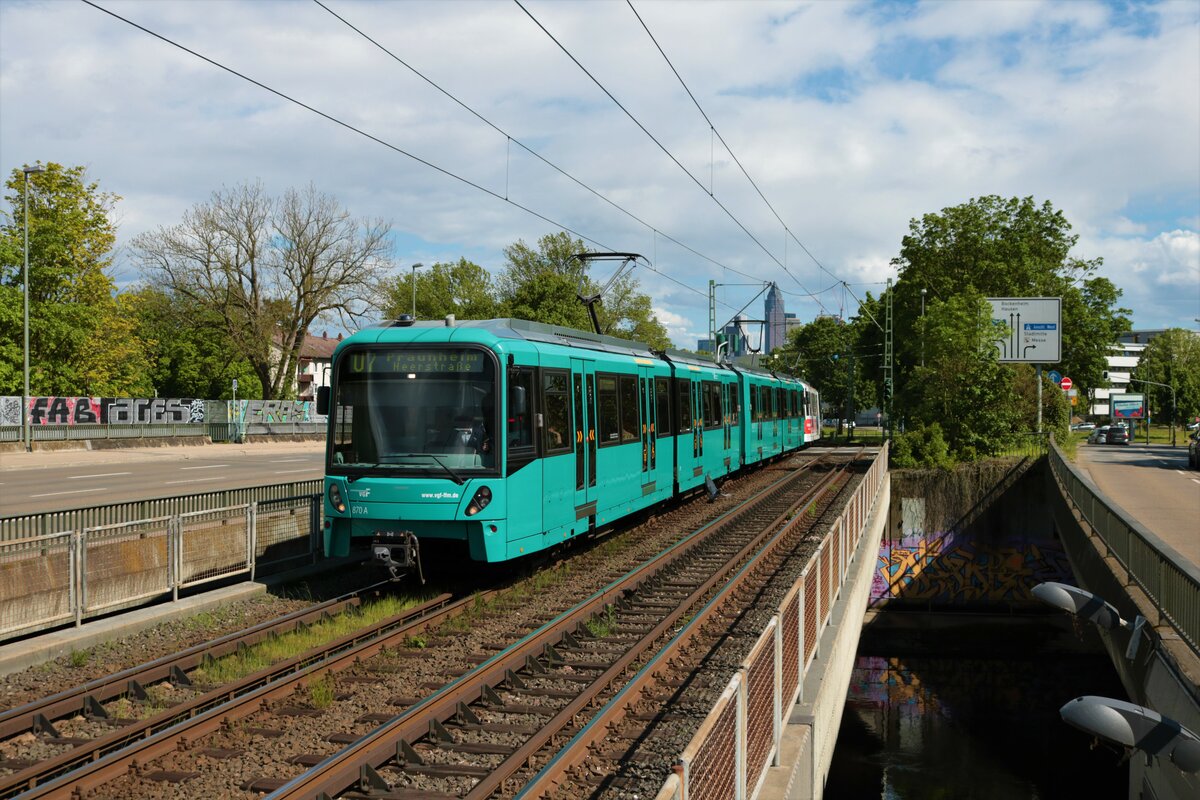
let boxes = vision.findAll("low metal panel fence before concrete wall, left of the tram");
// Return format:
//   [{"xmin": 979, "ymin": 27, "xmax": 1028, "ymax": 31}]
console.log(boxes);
[{"xmin": 0, "ymin": 496, "xmax": 322, "ymax": 638}]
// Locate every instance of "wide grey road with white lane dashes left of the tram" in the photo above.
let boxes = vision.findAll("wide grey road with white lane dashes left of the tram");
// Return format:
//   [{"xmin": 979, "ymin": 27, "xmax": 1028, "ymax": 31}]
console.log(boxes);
[{"xmin": 0, "ymin": 441, "xmax": 324, "ymax": 517}]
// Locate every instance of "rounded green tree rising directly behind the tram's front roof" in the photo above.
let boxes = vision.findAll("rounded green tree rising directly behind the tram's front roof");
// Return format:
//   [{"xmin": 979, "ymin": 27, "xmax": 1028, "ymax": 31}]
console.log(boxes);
[{"xmin": 383, "ymin": 258, "xmax": 499, "ymax": 319}]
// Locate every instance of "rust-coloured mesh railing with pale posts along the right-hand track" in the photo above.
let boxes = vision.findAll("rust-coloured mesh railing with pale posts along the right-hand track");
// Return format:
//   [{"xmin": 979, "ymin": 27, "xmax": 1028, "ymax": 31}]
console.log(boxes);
[{"xmin": 656, "ymin": 444, "xmax": 888, "ymax": 800}]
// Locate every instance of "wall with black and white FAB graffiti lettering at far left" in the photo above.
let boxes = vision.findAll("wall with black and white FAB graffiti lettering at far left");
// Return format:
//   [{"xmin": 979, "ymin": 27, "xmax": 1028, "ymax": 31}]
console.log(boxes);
[{"xmin": 0, "ymin": 397, "xmax": 205, "ymax": 426}]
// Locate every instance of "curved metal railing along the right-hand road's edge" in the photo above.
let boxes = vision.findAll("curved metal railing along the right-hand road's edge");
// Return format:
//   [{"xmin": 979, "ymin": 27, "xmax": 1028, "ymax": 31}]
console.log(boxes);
[{"xmin": 1050, "ymin": 443, "xmax": 1200, "ymax": 656}]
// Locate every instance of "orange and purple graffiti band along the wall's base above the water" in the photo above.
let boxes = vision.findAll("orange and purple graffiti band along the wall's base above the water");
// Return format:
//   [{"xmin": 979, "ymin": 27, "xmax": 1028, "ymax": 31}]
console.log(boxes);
[{"xmin": 871, "ymin": 535, "xmax": 1070, "ymax": 606}]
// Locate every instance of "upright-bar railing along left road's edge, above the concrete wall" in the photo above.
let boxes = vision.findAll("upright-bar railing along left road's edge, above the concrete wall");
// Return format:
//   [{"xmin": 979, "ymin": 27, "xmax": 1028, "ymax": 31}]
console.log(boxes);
[{"xmin": 0, "ymin": 479, "xmax": 324, "ymax": 542}]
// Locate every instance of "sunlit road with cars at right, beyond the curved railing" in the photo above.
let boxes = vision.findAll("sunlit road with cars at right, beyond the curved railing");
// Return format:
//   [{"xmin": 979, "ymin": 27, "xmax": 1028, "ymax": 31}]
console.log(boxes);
[{"xmin": 1075, "ymin": 444, "xmax": 1200, "ymax": 566}]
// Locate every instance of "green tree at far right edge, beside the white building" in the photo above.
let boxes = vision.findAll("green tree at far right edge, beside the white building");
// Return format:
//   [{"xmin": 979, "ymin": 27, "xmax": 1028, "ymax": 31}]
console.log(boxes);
[{"xmin": 1130, "ymin": 327, "xmax": 1200, "ymax": 425}]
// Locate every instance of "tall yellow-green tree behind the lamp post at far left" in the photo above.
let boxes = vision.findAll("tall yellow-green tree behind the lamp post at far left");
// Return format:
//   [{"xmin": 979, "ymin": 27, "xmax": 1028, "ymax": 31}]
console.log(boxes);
[{"xmin": 0, "ymin": 162, "xmax": 150, "ymax": 395}]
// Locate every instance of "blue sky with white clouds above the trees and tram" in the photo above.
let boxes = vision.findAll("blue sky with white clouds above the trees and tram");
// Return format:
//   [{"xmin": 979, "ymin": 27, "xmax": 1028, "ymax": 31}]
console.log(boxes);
[{"xmin": 0, "ymin": 0, "xmax": 1200, "ymax": 348}]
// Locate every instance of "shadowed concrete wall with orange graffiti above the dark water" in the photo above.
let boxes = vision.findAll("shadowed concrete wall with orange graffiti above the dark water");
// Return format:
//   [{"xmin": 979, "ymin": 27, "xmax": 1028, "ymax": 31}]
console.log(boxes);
[{"xmin": 871, "ymin": 465, "xmax": 1074, "ymax": 608}]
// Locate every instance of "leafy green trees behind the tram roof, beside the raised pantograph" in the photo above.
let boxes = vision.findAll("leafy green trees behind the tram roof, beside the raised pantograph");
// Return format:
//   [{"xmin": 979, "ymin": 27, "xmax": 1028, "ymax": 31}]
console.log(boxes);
[{"xmin": 497, "ymin": 233, "xmax": 671, "ymax": 349}]
